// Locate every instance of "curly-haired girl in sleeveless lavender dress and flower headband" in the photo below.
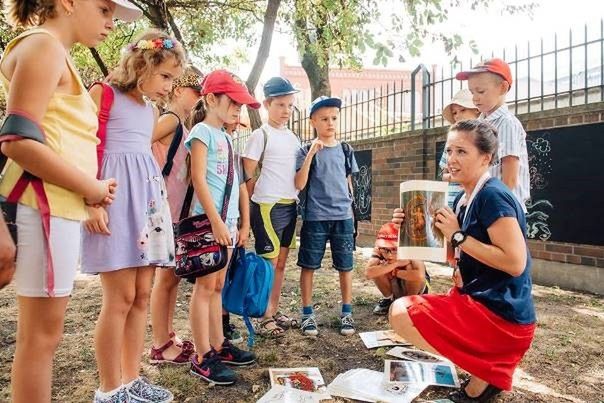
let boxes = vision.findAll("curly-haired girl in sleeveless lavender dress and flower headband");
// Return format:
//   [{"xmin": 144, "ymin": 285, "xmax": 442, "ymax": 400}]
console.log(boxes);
[{"xmin": 82, "ymin": 30, "xmax": 186, "ymax": 403}]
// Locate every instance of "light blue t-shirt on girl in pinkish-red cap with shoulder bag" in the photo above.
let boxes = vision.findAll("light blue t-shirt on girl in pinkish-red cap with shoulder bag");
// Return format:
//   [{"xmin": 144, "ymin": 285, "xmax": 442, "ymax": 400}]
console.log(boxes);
[{"xmin": 185, "ymin": 123, "xmax": 239, "ymax": 219}]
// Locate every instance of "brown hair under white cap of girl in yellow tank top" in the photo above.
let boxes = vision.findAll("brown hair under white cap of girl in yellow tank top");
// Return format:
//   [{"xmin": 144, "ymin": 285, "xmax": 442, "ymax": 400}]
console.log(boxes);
[{"xmin": 4, "ymin": 0, "xmax": 57, "ymax": 28}]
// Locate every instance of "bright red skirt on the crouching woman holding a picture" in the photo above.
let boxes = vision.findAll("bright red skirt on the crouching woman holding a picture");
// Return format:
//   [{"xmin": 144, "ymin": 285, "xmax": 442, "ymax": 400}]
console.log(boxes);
[{"xmin": 405, "ymin": 287, "xmax": 535, "ymax": 390}]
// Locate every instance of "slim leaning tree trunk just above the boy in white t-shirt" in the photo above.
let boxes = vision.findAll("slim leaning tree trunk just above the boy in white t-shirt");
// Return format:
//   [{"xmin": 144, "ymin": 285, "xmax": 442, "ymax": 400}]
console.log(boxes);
[{"xmin": 245, "ymin": 0, "xmax": 281, "ymax": 130}]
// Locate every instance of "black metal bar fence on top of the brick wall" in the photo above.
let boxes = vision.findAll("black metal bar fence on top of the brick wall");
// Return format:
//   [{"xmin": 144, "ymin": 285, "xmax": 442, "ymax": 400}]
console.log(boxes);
[{"xmin": 232, "ymin": 20, "xmax": 604, "ymax": 149}]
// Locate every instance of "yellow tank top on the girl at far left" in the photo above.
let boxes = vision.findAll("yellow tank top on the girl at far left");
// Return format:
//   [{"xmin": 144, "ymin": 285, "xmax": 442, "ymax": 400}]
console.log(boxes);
[{"xmin": 0, "ymin": 28, "xmax": 99, "ymax": 221}]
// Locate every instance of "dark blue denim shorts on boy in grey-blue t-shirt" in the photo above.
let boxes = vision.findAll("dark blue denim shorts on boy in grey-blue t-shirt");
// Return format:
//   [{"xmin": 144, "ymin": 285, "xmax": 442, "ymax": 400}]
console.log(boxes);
[{"xmin": 297, "ymin": 218, "xmax": 354, "ymax": 272}]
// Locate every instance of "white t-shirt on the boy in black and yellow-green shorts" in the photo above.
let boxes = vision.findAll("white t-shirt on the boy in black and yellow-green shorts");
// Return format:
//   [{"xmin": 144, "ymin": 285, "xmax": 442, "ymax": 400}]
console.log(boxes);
[{"xmin": 241, "ymin": 123, "xmax": 300, "ymax": 203}]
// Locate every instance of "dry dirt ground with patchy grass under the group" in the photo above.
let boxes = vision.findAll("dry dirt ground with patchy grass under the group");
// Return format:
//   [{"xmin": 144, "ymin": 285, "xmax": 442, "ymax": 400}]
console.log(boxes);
[{"xmin": 0, "ymin": 249, "xmax": 604, "ymax": 402}]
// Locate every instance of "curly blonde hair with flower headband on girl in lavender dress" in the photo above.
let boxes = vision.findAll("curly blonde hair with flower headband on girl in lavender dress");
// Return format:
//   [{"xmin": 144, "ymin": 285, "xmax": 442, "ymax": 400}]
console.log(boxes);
[{"xmin": 109, "ymin": 29, "xmax": 187, "ymax": 92}]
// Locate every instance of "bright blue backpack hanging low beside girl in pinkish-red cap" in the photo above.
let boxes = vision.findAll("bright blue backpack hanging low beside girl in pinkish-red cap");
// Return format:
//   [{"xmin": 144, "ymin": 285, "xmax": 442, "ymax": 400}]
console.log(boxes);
[{"xmin": 222, "ymin": 247, "xmax": 274, "ymax": 347}]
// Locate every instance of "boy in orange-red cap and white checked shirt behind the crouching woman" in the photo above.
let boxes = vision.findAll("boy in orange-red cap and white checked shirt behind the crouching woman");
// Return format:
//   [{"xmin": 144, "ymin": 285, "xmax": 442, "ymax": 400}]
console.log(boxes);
[{"xmin": 455, "ymin": 59, "xmax": 531, "ymax": 212}]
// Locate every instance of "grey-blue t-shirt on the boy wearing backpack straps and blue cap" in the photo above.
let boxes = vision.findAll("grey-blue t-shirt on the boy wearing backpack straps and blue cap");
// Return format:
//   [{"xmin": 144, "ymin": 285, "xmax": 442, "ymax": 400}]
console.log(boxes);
[{"xmin": 296, "ymin": 142, "xmax": 359, "ymax": 221}]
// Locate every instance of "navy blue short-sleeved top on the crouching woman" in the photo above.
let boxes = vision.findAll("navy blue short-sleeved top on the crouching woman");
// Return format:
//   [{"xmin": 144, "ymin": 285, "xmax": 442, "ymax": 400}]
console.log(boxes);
[{"xmin": 455, "ymin": 178, "xmax": 535, "ymax": 324}]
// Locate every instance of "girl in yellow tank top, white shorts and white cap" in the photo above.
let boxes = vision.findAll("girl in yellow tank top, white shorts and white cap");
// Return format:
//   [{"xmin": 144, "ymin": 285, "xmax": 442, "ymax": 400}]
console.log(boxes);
[{"xmin": 0, "ymin": 0, "xmax": 141, "ymax": 403}]
